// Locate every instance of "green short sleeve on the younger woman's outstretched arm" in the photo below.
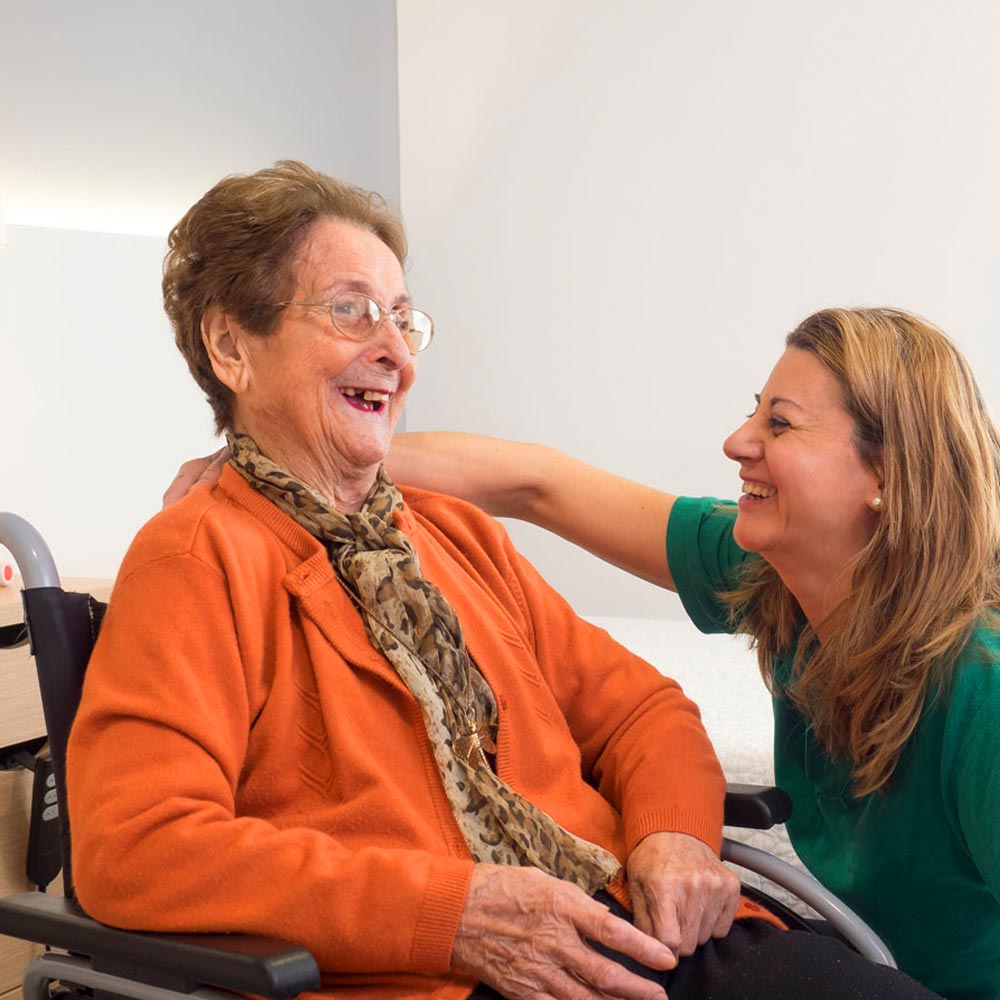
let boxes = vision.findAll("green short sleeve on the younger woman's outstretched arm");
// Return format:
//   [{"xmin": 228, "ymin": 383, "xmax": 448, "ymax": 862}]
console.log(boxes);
[{"xmin": 667, "ymin": 497, "xmax": 748, "ymax": 632}]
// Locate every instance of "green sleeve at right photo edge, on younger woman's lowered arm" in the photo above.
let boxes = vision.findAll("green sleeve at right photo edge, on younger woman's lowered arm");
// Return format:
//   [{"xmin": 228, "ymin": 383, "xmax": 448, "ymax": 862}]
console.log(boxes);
[{"xmin": 949, "ymin": 661, "xmax": 1000, "ymax": 902}]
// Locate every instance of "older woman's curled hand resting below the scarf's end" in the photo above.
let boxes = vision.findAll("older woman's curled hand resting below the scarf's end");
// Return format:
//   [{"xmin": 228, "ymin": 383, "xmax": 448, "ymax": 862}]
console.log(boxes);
[{"xmin": 628, "ymin": 833, "xmax": 740, "ymax": 956}]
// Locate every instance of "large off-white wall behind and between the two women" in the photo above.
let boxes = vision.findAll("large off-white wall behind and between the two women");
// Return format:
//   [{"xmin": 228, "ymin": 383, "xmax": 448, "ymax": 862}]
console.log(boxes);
[{"xmin": 398, "ymin": 0, "xmax": 1000, "ymax": 615}]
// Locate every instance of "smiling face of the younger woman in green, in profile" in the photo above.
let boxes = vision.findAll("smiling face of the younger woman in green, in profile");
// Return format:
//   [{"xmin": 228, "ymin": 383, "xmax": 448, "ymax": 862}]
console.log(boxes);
[{"xmin": 723, "ymin": 348, "xmax": 880, "ymax": 581}]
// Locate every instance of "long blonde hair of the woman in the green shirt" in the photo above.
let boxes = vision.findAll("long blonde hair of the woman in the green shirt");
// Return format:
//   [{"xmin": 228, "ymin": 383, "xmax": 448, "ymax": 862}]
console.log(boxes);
[{"xmin": 723, "ymin": 309, "xmax": 1000, "ymax": 797}]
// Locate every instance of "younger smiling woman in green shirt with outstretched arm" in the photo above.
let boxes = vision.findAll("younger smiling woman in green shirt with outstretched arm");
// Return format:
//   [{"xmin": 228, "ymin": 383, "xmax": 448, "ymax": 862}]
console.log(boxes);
[{"xmin": 382, "ymin": 309, "xmax": 1000, "ymax": 1000}]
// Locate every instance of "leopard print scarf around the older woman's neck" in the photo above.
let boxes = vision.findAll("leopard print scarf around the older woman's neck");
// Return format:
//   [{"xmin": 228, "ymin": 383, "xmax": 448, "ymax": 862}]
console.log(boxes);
[{"xmin": 229, "ymin": 434, "xmax": 621, "ymax": 895}]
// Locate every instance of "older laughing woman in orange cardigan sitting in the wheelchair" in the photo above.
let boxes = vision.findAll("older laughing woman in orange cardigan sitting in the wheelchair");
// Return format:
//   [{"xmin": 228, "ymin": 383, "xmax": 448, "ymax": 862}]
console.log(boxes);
[{"xmin": 68, "ymin": 163, "xmax": 928, "ymax": 1000}]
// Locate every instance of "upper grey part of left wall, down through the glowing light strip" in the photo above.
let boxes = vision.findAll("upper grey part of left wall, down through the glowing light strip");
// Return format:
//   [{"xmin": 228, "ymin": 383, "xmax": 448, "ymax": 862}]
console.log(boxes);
[{"xmin": 0, "ymin": 0, "xmax": 399, "ymax": 236}]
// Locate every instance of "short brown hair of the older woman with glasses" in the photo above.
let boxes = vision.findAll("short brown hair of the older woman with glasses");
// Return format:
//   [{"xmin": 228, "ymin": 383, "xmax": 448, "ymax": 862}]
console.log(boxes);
[{"xmin": 163, "ymin": 160, "xmax": 406, "ymax": 431}]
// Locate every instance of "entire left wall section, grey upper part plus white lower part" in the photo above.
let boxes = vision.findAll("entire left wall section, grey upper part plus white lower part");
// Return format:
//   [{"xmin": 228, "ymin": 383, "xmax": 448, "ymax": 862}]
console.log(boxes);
[{"xmin": 0, "ymin": 0, "xmax": 399, "ymax": 575}]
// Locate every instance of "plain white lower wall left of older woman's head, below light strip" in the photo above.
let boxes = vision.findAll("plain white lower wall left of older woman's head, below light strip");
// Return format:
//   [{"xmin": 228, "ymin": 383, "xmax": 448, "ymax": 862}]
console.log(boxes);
[{"xmin": 0, "ymin": 226, "xmax": 203, "ymax": 576}]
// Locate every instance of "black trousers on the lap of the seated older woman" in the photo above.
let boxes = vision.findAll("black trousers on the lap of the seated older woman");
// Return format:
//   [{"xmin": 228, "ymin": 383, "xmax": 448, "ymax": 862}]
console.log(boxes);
[{"xmin": 469, "ymin": 891, "xmax": 937, "ymax": 1000}]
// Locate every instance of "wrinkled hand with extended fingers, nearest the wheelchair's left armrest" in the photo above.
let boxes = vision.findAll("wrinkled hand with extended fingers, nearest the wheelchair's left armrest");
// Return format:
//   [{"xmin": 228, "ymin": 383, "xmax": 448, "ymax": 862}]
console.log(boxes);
[{"xmin": 452, "ymin": 864, "xmax": 677, "ymax": 1000}]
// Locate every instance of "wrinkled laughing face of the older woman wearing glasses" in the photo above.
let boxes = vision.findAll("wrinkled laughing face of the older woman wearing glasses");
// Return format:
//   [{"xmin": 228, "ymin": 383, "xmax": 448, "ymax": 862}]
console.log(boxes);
[{"xmin": 226, "ymin": 219, "xmax": 415, "ymax": 509}]
